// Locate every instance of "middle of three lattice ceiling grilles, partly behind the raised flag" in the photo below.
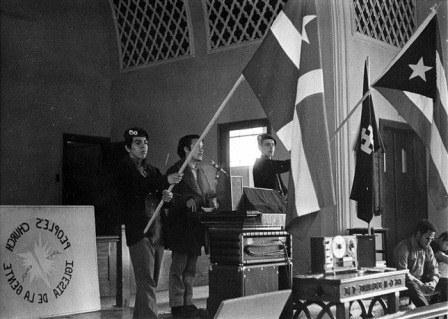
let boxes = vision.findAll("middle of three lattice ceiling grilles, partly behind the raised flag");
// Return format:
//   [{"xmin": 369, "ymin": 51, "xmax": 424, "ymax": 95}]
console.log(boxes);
[{"xmin": 203, "ymin": 0, "xmax": 286, "ymax": 52}]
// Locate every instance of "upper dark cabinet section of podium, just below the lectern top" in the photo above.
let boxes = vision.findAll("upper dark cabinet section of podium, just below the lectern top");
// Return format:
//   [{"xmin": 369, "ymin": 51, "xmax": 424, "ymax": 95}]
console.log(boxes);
[{"xmin": 209, "ymin": 229, "xmax": 292, "ymax": 265}]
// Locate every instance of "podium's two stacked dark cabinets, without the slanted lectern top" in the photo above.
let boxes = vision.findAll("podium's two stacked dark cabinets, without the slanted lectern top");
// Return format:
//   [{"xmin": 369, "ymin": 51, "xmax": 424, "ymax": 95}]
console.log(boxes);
[{"xmin": 207, "ymin": 227, "xmax": 292, "ymax": 317}]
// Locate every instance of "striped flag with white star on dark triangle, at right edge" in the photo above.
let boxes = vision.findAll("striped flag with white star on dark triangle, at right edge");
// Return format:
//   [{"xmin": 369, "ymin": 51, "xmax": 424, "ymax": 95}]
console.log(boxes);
[{"xmin": 374, "ymin": 12, "xmax": 448, "ymax": 209}]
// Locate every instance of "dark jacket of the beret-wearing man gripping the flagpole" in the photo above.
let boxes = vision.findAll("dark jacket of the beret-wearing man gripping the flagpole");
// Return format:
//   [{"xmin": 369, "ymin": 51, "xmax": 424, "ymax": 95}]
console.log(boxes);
[{"xmin": 115, "ymin": 156, "xmax": 169, "ymax": 246}]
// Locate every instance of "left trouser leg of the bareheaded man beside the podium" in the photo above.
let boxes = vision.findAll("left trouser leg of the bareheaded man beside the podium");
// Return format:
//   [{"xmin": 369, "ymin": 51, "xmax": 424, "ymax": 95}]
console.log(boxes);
[{"xmin": 168, "ymin": 251, "xmax": 187, "ymax": 308}]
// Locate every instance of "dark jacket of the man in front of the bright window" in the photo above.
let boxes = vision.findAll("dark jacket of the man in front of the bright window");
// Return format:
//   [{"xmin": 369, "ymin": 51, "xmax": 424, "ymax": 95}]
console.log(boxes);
[{"xmin": 252, "ymin": 157, "xmax": 291, "ymax": 195}]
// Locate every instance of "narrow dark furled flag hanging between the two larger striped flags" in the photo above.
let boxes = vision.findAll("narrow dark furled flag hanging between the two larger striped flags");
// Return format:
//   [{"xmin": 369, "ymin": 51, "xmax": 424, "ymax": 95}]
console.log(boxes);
[{"xmin": 350, "ymin": 61, "xmax": 380, "ymax": 223}]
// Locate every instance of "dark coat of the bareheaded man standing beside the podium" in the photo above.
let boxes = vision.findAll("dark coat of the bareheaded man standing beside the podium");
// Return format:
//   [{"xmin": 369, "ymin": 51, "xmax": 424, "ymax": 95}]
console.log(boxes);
[{"xmin": 165, "ymin": 161, "xmax": 215, "ymax": 256}]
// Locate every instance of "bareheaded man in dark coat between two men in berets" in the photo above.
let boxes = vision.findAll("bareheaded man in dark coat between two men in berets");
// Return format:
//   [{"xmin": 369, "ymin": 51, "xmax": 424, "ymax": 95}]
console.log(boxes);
[{"xmin": 167, "ymin": 135, "xmax": 216, "ymax": 318}]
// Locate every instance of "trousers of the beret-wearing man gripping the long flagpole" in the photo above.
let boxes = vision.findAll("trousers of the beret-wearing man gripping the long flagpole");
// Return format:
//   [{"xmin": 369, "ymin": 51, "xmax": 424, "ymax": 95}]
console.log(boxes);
[{"xmin": 129, "ymin": 238, "xmax": 157, "ymax": 319}]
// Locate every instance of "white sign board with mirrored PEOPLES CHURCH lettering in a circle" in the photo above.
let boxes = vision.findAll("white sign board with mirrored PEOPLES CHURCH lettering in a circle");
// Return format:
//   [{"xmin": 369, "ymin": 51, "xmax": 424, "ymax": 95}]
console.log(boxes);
[{"xmin": 0, "ymin": 206, "xmax": 101, "ymax": 319}]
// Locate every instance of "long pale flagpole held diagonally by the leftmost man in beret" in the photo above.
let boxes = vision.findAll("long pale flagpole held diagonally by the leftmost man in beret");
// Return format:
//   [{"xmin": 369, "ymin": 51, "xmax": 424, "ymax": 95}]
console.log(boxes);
[{"xmin": 143, "ymin": 74, "xmax": 244, "ymax": 233}]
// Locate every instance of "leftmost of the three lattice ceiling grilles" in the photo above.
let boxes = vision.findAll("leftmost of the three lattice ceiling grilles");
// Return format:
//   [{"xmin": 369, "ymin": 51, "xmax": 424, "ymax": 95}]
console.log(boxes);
[{"xmin": 110, "ymin": 0, "xmax": 192, "ymax": 70}]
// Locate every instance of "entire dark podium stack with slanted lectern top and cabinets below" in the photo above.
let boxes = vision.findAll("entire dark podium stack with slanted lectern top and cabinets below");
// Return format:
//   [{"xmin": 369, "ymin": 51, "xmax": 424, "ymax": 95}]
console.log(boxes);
[{"xmin": 202, "ymin": 187, "xmax": 292, "ymax": 318}]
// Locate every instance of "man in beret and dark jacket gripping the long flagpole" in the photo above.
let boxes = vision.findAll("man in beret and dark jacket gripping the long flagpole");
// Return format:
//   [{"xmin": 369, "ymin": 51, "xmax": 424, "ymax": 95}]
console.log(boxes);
[{"xmin": 115, "ymin": 127, "xmax": 181, "ymax": 319}]
